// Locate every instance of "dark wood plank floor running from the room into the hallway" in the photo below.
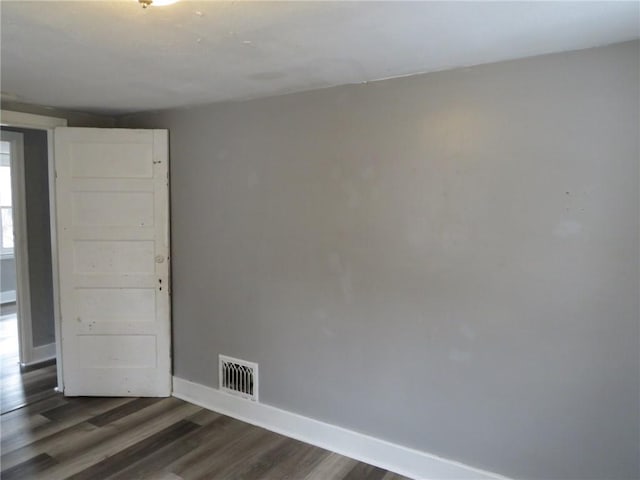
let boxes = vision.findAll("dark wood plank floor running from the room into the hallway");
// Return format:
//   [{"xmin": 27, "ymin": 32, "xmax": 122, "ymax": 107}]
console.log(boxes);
[{"xmin": 0, "ymin": 304, "xmax": 404, "ymax": 480}]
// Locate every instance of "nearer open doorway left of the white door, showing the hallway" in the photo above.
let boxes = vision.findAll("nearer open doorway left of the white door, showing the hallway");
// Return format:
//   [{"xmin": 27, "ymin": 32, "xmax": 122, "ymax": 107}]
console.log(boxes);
[{"xmin": 0, "ymin": 122, "xmax": 57, "ymax": 413}]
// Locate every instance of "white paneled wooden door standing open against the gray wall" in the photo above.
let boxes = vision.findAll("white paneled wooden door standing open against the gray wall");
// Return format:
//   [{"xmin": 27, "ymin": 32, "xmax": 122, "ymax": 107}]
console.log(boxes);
[{"xmin": 55, "ymin": 127, "xmax": 171, "ymax": 396}]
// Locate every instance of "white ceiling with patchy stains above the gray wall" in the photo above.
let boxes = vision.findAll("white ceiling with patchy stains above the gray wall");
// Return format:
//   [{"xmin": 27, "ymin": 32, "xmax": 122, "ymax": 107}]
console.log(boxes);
[{"xmin": 0, "ymin": 0, "xmax": 640, "ymax": 114}]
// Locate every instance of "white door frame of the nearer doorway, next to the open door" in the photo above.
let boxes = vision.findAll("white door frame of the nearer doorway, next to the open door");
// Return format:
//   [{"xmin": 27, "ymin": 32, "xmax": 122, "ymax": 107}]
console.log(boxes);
[{"xmin": 0, "ymin": 110, "xmax": 67, "ymax": 392}]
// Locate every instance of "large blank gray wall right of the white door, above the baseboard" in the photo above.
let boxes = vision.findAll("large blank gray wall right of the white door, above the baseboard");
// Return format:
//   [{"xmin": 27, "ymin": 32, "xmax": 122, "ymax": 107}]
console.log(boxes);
[{"xmin": 121, "ymin": 42, "xmax": 640, "ymax": 479}]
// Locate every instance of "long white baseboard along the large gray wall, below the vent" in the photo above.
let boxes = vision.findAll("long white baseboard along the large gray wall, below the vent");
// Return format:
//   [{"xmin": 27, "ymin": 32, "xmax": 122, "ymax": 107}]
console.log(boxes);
[{"xmin": 173, "ymin": 377, "xmax": 506, "ymax": 480}]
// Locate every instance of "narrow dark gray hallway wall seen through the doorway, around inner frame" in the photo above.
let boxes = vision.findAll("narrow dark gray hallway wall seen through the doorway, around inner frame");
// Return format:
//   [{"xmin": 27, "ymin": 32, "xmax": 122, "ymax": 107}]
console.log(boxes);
[{"xmin": 2, "ymin": 127, "xmax": 55, "ymax": 347}]
